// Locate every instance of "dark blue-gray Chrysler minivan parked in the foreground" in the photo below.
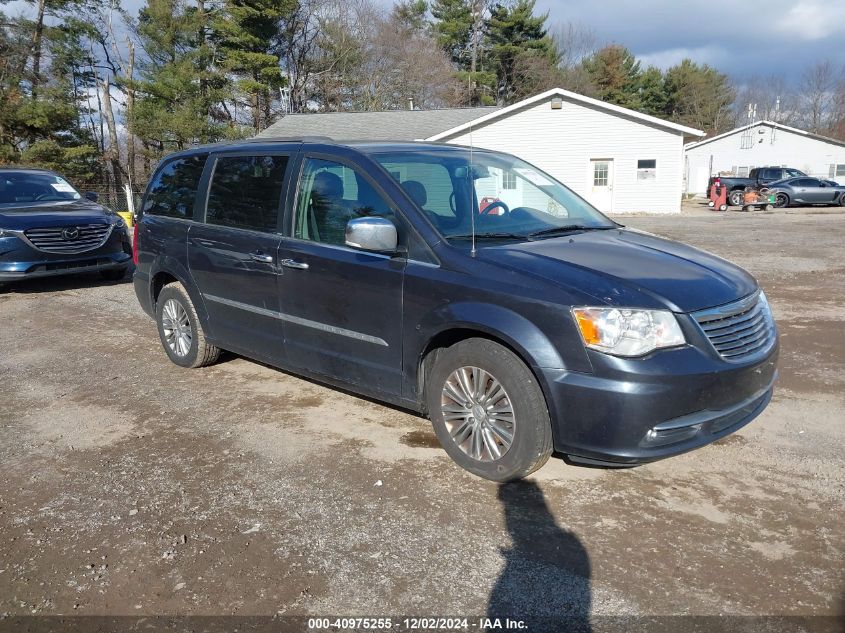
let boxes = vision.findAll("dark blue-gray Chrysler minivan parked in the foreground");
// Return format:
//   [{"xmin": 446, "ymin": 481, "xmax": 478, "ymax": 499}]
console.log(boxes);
[{"xmin": 134, "ymin": 139, "xmax": 778, "ymax": 481}]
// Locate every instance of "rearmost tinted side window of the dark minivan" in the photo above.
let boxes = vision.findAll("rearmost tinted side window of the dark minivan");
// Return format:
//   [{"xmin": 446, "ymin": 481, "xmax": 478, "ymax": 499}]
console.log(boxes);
[{"xmin": 141, "ymin": 154, "xmax": 208, "ymax": 220}]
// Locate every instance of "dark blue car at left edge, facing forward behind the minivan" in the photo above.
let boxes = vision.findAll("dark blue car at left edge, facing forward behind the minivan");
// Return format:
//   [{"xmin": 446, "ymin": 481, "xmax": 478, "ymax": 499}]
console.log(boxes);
[{"xmin": 0, "ymin": 168, "xmax": 132, "ymax": 286}]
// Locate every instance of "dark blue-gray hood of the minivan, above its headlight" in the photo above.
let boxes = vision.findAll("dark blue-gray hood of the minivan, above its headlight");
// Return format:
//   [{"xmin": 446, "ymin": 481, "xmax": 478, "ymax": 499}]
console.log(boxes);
[{"xmin": 478, "ymin": 229, "xmax": 758, "ymax": 312}]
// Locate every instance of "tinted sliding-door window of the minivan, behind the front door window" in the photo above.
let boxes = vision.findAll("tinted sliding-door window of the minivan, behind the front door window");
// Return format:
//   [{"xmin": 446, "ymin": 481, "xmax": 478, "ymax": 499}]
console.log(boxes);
[{"xmin": 205, "ymin": 156, "xmax": 288, "ymax": 232}]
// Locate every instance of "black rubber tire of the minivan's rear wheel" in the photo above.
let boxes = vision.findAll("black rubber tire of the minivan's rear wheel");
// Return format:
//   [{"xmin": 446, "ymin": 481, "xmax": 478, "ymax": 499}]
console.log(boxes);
[{"xmin": 156, "ymin": 282, "xmax": 220, "ymax": 368}]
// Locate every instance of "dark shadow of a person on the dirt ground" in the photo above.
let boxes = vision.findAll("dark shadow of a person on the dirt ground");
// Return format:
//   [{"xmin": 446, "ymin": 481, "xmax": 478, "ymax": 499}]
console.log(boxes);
[{"xmin": 487, "ymin": 481, "xmax": 592, "ymax": 632}]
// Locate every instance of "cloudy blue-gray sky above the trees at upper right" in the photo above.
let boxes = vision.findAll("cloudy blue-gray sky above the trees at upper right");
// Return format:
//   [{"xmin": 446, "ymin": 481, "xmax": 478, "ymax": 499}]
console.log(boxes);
[{"xmin": 537, "ymin": 0, "xmax": 845, "ymax": 82}]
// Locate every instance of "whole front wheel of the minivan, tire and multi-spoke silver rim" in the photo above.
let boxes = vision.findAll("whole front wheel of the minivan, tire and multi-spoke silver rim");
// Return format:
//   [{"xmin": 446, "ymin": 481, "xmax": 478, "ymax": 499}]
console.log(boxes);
[{"xmin": 426, "ymin": 338, "xmax": 552, "ymax": 481}]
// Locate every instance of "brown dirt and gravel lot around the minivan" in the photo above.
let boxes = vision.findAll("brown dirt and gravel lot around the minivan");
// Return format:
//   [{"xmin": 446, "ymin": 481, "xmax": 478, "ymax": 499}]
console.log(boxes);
[{"xmin": 0, "ymin": 205, "xmax": 845, "ymax": 630}]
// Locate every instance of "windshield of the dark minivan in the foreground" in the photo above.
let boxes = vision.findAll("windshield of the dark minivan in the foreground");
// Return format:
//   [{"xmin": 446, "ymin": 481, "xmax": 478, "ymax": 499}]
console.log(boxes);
[{"xmin": 374, "ymin": 148, "xmax": 617, "ymax": 239}]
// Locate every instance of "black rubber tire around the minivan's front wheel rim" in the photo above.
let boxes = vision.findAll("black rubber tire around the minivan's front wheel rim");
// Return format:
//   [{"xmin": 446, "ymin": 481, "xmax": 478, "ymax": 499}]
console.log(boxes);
[{"xmin": 426, "ymin": 338, "xmax": 552, "ymax": 482}]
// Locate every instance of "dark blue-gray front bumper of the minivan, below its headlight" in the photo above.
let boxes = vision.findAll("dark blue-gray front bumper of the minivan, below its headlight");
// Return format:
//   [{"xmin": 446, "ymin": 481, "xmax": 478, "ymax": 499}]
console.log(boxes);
[{"xmin": 540, "ymin": 342, "xmax": 779, "ymax": 466}]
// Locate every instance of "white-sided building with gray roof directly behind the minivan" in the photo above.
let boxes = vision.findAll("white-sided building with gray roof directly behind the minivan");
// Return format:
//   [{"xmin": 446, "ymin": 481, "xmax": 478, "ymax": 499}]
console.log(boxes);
[{"xmin": 260, "ymin": 88, "xmax": 704, "ymax": 213}]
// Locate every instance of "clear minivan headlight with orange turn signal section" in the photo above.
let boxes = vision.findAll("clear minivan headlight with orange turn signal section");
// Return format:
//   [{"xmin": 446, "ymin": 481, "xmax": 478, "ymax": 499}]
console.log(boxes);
[{"xmin": 572, "ymin": 308, "xmax": 686, "ymax": 356}]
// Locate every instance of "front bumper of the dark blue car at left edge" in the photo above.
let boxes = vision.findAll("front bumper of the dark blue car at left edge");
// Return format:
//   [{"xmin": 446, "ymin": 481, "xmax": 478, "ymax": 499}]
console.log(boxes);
[{"xmin": 0, "ymin": 230, "xmax": 132, "ymax": 282}]
